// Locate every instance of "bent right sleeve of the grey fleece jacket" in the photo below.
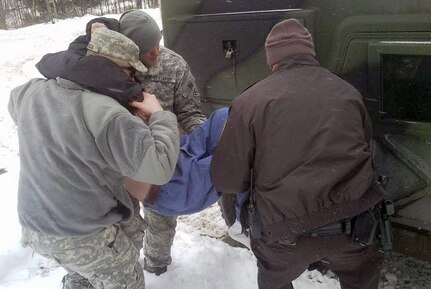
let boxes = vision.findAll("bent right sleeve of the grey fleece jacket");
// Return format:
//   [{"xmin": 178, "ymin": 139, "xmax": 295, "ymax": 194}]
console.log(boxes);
[{"xmin": 83, "ymin": 95, "xmax": 179, "ymax": 185}]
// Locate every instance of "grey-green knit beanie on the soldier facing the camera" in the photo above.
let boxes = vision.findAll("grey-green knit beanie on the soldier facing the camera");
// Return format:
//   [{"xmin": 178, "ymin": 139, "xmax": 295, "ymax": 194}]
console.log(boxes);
[{"xmin": 120, "ymin": 10, "xmax": 162, "ymax": 53}]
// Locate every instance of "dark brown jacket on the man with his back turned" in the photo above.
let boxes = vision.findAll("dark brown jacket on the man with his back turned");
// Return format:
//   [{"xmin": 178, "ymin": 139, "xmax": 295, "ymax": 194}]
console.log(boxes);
[{"xmin": 212, "ymin": 55, "xmax": 382, "ymax": 241}]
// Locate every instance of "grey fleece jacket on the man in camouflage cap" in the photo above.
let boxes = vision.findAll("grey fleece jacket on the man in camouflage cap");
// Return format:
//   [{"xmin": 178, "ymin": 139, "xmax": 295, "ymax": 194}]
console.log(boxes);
[{"xmin": 9, "ymin": 79, "xmax": 179, "ymax": 237}]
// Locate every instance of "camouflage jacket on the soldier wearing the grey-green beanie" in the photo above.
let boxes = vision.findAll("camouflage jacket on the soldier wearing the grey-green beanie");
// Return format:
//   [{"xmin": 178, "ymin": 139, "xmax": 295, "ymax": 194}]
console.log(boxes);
[{"xmin": 137, "ymin": 47, "xmax": 206, "ymax": 133}]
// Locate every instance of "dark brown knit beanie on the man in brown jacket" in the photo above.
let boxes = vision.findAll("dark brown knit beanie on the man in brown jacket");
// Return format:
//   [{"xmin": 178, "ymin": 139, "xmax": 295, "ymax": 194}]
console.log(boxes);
[{"xmin": 265, "ymin": 18, "xmax": 316, "ymax": 66}]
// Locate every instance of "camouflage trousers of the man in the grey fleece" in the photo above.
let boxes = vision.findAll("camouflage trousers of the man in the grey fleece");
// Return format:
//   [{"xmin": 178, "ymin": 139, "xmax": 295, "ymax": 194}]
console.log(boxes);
[{"xmin": 21, "ymin": 201, "xmax": 146, "ymax": 289}]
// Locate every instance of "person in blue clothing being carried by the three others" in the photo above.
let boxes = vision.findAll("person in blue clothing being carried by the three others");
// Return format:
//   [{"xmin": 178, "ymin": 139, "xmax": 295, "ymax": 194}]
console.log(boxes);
[{"xmin": 126, "ymin": 108, "xmax": 250, "ymax": 248}]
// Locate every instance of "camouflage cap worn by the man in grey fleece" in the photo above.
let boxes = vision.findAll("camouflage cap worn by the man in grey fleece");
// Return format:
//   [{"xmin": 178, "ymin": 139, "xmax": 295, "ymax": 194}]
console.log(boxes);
[{"xmin": 87, "ymin": 28, "xmax": 148, "ymax": 73}]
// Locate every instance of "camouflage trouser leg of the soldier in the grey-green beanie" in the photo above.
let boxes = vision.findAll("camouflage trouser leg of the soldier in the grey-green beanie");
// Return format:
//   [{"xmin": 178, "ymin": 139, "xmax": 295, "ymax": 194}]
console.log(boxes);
[{"xmin": 144, "ymin": 207, "xmax": 177, "ymax": 267}]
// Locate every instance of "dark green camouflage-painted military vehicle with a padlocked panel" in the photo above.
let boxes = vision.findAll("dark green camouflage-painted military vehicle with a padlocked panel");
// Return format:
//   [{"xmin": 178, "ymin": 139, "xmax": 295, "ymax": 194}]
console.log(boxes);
[{"xmin": 161, "ymin": 0, "xmax": 431, "ymax": 261}]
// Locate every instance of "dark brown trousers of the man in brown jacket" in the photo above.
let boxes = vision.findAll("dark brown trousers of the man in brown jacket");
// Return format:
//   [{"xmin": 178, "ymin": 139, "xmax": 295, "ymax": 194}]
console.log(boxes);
[{"xmin": 251, "ymin": 235, "xmax": 383, "ymax": 289}]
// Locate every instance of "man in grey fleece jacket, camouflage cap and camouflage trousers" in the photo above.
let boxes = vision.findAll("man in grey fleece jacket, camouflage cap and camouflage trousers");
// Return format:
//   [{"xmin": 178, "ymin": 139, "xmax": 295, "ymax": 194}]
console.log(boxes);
[{"xmin": 9, "ymin": 23, "xmax": 179, "ymax": 289}]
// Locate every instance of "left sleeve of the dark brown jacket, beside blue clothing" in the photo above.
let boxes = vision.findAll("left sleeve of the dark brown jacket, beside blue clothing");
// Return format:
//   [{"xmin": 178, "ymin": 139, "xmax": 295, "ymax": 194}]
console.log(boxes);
[{"xmin": 211, "ymin": 105, "xmax": 255, "ymax": 194}]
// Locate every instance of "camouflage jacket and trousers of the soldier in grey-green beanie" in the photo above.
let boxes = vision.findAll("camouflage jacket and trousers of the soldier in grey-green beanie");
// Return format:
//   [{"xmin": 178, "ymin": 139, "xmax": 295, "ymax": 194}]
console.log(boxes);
[{"xmin": 137, "ymin": 46, "xmax": 206, "ymax": 267}]
